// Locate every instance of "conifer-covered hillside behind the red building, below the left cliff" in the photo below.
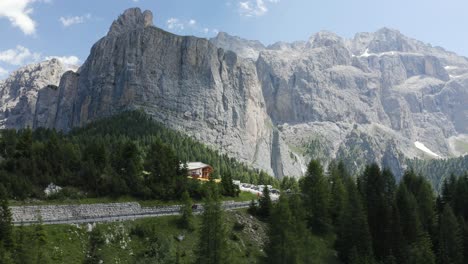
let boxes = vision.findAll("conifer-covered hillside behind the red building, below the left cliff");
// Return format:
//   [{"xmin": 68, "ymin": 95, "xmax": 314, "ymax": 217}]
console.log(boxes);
[{"xmin": 0, "ymin": 111, "xmax": 276, "ymax": 199}]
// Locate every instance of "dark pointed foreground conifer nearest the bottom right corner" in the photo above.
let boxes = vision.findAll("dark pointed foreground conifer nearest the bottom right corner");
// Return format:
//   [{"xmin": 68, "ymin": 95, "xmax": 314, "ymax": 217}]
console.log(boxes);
[{"xmin": 437, "ymin": 205, "xmax": 463, "ymax": 264}]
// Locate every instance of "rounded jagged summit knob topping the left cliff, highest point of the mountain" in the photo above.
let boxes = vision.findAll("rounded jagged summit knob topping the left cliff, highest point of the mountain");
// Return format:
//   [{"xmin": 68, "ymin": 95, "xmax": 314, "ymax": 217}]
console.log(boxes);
[{"xmin": 107, "ymin": 7, "xmax": 153, "ymax": 36}]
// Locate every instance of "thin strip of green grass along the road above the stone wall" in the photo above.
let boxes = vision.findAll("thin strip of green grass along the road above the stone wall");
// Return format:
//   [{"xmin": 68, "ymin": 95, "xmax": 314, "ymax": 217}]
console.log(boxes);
[{"xmin": 9, "ymin": 192, "xmax": 258, "ymax": 207}]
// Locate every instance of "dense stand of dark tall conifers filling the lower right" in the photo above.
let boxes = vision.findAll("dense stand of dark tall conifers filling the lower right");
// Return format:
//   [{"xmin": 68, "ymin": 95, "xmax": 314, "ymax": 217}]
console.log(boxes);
[{"xmin": 264, "ymin": 161, "xmax": 468, "ymax": 264}]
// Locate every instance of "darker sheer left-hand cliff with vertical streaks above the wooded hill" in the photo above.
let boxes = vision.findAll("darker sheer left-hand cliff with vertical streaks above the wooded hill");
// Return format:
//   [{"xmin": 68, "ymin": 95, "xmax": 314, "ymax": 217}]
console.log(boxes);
[{"xmin": 30, "ymin": 9, "xmax": 304, "ymax": 175}]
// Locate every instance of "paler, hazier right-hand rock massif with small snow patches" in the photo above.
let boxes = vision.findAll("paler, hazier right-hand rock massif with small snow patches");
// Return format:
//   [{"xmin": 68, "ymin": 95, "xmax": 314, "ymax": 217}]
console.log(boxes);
[{"xmin": 243, "ymin": 28, "xmax": 468, "ymax": 177}]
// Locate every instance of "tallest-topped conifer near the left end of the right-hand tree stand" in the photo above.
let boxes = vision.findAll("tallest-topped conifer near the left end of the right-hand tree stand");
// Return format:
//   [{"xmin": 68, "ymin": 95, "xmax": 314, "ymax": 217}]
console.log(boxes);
[{"xmin": 301, "ymin": 160, "xmax": 331, "ymax": 234}]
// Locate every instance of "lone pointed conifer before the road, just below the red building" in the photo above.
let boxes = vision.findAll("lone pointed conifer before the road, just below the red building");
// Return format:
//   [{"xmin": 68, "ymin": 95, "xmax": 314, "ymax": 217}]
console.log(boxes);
[{"xmin": 196, "ymin": 183, "xmax": 230, "ymax": 264}]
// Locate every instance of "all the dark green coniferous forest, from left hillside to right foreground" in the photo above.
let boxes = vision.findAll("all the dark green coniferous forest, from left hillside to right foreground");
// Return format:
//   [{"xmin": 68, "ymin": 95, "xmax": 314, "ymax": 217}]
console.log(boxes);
[{"xmin": 0, "ymin": 112, "xmax": 468, "ymax": 264}]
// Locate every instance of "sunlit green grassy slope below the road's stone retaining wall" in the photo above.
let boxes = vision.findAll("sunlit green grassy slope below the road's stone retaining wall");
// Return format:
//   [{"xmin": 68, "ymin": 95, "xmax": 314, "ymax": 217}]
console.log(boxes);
[{"xmin": 16, "ymin": 210, "xmax": 265, "ymax": 264}]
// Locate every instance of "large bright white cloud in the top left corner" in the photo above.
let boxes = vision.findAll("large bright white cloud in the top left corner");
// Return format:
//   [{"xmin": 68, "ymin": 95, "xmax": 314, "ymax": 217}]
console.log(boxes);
[{"xmin": 0, "ymin": 0, "xmax": 38, "ymax": 35}]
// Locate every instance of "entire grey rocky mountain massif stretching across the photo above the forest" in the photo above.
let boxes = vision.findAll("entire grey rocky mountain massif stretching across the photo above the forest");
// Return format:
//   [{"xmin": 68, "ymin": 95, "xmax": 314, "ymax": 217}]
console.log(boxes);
[{"xmin": 0, "ymin": 9, "xmax": 468, "ymax": 177}]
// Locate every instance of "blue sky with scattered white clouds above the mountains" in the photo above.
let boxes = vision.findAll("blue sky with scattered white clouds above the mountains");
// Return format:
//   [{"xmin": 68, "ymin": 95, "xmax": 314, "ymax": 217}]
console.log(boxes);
[{"xmin": 0, "ymin": 0, "xmax": 468, "ymax": 78}]
